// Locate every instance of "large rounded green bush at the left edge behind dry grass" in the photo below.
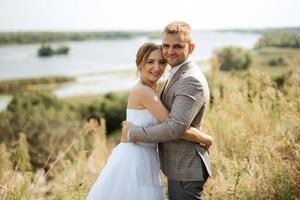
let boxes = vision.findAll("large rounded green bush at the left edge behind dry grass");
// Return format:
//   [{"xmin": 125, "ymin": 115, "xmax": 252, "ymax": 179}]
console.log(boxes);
[{"xmin": 0, "ymin": 91, "xmax": 80, "ymax": 169}]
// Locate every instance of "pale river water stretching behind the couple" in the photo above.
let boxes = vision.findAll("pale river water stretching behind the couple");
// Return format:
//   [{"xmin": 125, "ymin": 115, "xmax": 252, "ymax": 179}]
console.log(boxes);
[{"xmin": 0, "ymin": 31, "xmax": 260, "ymax": 110}]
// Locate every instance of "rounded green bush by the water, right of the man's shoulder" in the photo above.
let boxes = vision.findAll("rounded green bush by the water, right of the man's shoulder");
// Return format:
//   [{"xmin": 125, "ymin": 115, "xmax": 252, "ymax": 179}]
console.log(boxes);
[{"xmin": 215, "ymin": 47, "xmax": 251, "ymax": 71}]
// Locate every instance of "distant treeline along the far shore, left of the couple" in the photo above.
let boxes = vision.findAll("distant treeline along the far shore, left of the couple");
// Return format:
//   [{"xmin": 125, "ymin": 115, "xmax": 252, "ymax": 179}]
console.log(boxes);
[{"xmin": 0, "ymin": 31, "xmax": 161, "ymax": 45}]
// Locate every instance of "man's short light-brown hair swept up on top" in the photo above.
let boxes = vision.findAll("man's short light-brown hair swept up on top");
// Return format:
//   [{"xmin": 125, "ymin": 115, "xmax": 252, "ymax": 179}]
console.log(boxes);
[{"xmin": 163, "ymin": 21, "xmax": 192, "ymax": 42}]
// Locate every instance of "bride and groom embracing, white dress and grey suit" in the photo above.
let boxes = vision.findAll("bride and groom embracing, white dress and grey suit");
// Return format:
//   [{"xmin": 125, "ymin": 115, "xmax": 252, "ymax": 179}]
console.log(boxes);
[{"xmin": 87, "ymin": 21, "xmax": 212, "ymax": 200}]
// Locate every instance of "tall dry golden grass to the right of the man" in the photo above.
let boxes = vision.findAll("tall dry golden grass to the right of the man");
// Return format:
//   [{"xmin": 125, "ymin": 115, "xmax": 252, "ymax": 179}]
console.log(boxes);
[{"xmin": 204, "ymin": 57, "xmax": 300, "ymax": 199}]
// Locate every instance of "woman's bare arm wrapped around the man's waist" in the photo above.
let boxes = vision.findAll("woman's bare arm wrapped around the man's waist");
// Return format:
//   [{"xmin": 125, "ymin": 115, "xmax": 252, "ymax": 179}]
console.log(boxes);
[{"xmin": 124, "ymin": 86, "xmax": 212, "ymax": 149}]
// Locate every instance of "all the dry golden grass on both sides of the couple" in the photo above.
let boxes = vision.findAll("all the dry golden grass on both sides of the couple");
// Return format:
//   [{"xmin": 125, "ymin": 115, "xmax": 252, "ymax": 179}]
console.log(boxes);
[{"xmin": 0, "ymin": 61, "xmax": 300, "ymax": 200}]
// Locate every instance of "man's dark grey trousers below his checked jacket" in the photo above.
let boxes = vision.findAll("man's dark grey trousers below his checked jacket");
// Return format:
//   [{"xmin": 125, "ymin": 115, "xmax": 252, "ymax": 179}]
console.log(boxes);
[{"xmin": 168, "ymin": 178, "xmax": 207, "ymax": 200}]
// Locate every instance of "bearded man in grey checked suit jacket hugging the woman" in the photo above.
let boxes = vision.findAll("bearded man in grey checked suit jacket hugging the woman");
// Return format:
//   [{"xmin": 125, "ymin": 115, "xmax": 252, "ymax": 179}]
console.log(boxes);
[{"xmin": 122, "ymin": 21, "xmax": 211, "ymax": 200}]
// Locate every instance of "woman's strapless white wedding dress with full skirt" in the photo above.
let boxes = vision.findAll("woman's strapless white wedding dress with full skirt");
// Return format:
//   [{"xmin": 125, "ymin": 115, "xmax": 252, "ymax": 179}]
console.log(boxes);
[{"xmin": 87, "ymin": 109, "xmax": 164, "ymax": 200}]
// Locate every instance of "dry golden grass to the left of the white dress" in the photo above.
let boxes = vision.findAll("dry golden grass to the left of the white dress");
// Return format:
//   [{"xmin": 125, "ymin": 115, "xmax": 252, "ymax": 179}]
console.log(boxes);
[{"xmin": 0, "ymin": 120, "xmax": 112, "ymax": 200}]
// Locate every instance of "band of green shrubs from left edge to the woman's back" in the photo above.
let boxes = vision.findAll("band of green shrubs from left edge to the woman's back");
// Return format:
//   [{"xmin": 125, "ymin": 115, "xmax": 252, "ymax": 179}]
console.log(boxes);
[{"xmin": 0, "ymin": 91, "xmax": 127, "ymax": 169}]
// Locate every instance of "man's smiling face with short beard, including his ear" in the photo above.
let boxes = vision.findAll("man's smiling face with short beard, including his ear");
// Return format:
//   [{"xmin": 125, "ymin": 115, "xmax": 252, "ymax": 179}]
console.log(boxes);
[{"xmin": 162, "ymin": 33, "xmax": 194, "ymax": 67}]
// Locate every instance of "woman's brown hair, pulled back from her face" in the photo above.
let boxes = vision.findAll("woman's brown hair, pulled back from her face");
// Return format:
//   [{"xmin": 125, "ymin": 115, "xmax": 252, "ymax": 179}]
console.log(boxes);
[{"xmin": 135, "ymin": 42, "xmax": 161, "ymax": 67}]
